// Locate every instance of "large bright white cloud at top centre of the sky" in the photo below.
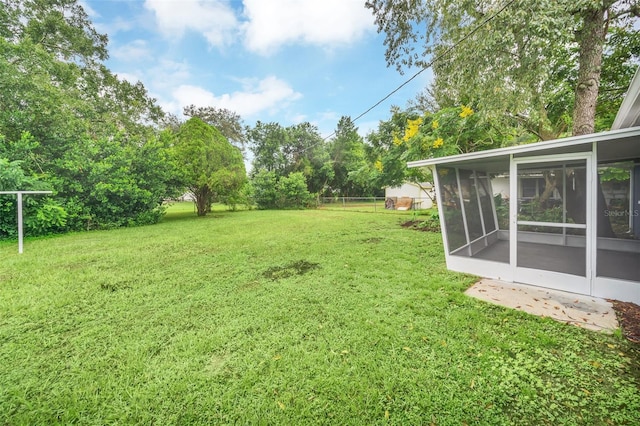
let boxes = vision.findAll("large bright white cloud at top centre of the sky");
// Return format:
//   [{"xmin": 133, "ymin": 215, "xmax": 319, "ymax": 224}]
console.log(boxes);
[{"xmin": 243, "ymin": 0, "xmax": 374, "ymax": 55}]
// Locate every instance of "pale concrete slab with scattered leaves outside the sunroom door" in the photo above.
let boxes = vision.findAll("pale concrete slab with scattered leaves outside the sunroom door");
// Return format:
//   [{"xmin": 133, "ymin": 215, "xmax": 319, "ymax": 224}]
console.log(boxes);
[{"xmin": 465, "ymin": 279, "xmax": 618, "ymax": 333}]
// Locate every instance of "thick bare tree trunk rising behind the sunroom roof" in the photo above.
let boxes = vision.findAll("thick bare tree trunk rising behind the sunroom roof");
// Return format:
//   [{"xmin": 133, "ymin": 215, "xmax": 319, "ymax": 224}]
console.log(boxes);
[{"xmin": 573, "ymin": 9, "xmax": 605, "ymax": 136}]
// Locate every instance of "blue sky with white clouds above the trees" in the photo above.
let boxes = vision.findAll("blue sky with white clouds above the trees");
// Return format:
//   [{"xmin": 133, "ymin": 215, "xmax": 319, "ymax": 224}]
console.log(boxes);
[{"xmin": 81, "ymin": 0, "xmax": 431, "ymax": 136}]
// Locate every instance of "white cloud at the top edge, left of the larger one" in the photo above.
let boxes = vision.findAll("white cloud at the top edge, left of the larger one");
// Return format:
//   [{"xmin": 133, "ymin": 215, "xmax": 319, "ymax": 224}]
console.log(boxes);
[{"xmin": 144, "ymin": 0, "xmax": 238, "ymax": 47}]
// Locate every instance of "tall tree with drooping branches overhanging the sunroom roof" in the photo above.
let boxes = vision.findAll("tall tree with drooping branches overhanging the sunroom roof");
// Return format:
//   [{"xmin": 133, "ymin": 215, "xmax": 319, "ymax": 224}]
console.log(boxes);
[{"xmin": 366, "ymin": 0, "xmax": 640, "ymax": 139}]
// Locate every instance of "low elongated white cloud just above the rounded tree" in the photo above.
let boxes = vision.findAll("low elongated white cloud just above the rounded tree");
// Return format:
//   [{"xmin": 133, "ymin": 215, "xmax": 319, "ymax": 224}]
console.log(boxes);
[{"xmin": 172, "ymin": 76, "xmax": 302, "ymax": 118}]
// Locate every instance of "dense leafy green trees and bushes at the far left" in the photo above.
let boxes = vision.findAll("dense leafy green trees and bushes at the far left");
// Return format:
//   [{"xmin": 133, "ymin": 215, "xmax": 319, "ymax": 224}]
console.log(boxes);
[{"xmin": 0, "ymin": 0, "xmax": 178, "ymax": 235}]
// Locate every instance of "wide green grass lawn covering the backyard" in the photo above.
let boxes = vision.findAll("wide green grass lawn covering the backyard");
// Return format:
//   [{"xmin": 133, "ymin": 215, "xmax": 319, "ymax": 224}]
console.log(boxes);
[{"xmin": 0, "ymin": 204, "xmax": 640, "ymax": 425}]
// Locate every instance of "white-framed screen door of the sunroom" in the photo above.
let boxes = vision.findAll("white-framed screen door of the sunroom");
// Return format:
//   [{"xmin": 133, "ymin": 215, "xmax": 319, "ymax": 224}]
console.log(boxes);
[{"xmin": 509, "ymin": 153, "xmax": 593, "ymax": 294}]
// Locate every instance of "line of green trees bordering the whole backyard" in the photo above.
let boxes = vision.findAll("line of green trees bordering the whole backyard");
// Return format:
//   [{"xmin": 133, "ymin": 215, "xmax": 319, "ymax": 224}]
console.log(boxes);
[{"xmin": 0, "ymin": 0, "xmax": 640, "ymax": 238}]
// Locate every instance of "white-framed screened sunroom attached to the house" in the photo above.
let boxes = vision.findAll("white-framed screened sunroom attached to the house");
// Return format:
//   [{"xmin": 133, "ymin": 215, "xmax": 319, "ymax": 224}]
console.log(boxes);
[{"xmin": 409, "ymin": 73, "xmax": 640, "ymax": 304}]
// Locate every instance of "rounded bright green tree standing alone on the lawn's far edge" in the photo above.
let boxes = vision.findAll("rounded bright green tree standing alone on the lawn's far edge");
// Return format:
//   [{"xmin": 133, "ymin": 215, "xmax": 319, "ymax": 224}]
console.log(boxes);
[{"xmin": 174, "ymin": 117, "xmax": 246, "ymax": 216}]
